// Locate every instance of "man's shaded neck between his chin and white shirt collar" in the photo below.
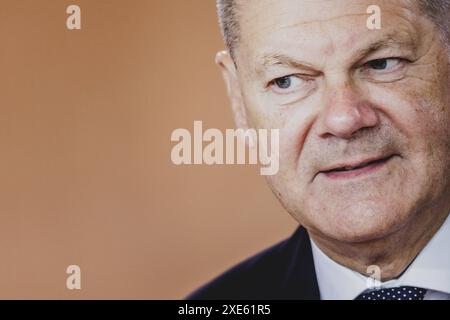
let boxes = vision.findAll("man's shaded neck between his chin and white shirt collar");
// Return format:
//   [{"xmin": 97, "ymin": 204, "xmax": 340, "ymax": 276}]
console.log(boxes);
[{"xmin": 308, "ymin": 209, "xmax": 449, "ymax": 281}]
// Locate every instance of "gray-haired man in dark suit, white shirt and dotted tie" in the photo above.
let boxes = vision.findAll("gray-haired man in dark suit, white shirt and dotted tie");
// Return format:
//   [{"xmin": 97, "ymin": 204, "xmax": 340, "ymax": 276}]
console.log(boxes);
[{"xmin": 187, "ymin": 0, "xmax": 450, "ymax": 300}]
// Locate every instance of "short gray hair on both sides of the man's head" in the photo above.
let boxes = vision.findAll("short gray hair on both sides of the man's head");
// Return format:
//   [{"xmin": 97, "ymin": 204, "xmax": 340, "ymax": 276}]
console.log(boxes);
[{"xmin": 216, "ymin": 0, "xmax": 450, "ymax": 54}]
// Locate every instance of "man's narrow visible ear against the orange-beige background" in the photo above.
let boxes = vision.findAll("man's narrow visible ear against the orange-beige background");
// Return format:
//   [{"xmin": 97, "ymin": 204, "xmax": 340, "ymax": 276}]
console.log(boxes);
[{"xmin": 216, "ymin": 51, "xmax": 249, "ymax": 130}]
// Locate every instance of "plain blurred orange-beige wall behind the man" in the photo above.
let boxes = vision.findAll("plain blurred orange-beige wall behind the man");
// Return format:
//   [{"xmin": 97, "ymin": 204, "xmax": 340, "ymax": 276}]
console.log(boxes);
[{"xmin": 0, "ymin": 0, "xmax": 296, "ymax": 299}]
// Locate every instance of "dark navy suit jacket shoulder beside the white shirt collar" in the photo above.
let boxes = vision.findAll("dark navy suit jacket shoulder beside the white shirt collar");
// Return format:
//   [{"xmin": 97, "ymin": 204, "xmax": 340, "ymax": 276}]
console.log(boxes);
[{"xmin": 187, "ymin": 227, "xmax": 320, "ymax": 300}]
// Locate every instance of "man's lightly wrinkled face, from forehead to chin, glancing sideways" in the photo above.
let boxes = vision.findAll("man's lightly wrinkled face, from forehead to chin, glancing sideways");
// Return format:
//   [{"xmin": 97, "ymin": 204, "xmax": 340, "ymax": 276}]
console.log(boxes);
[{"xmin": 225, "ymin": 0, "xmax": 450, "ymax": 242}]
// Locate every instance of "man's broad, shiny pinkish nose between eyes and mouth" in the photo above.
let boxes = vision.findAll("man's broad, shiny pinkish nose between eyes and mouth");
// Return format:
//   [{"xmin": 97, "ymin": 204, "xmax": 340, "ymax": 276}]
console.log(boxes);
[{"xmin": 320, "ymin": 81, "xmax": 379, "ymax": 139}]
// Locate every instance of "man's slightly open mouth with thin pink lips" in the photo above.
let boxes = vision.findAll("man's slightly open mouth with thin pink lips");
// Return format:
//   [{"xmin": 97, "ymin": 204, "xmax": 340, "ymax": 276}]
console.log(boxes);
[{"xmin": 316, "ymin": 154, "xmax": 398, "ymax": 179}]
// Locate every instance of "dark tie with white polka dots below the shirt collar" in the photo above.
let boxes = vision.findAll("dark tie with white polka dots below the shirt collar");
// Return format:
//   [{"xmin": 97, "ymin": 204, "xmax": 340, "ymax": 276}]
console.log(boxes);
[{"xmin": 355, "ymin": 286, "xmax": 427, "ymax": 300}]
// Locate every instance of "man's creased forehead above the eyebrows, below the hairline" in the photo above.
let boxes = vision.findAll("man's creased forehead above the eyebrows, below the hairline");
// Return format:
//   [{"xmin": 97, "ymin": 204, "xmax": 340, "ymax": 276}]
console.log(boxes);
[{"xmin": 239, "ymin": 0, "xmax": 419, "ymax": 63}]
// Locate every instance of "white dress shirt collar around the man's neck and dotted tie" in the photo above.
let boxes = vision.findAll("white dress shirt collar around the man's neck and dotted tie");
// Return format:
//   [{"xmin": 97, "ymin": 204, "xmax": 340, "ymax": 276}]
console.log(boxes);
[{"xmin": 311, "ymin": 212, "xmax": 450, "ymax": 300}]
